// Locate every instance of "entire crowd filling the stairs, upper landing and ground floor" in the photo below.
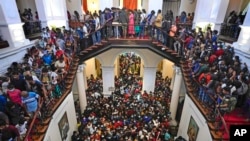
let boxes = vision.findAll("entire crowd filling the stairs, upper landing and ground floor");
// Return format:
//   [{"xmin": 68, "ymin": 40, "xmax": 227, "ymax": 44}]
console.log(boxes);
[{"xmin": 0, "ymin": 4, "xmax": 250, "ymax": 141}]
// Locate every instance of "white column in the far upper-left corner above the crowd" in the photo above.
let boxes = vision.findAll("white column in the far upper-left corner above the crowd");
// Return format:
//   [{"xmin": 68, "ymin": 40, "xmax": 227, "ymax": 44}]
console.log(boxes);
[{"xmin": 0, "ymin": 0, "xmax": 30, "ymax": 48}]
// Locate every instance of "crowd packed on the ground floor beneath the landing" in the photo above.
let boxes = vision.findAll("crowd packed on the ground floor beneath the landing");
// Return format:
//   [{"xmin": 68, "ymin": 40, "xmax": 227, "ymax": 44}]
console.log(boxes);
[{"xmin": 71, "ymin": 52, "xmax": 173, "ymax": 141}]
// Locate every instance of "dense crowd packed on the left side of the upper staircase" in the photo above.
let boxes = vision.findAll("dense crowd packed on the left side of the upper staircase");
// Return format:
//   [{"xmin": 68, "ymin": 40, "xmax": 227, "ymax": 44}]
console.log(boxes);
[{"xmin": 0, "ymin": 21, "xmax": 75, "ymax": 141}]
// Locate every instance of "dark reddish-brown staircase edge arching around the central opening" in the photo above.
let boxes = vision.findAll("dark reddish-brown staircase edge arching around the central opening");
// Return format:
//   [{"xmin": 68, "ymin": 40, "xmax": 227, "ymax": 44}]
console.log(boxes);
[{"xmin": 23, "ymin": 20, "xmax": 250, "ymax": 141}]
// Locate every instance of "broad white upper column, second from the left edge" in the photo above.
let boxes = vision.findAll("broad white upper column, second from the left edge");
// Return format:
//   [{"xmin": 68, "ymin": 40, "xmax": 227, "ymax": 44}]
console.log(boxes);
[{"xmin": 35, "ymin": 0, "xmax": 68, "ymax": 28}]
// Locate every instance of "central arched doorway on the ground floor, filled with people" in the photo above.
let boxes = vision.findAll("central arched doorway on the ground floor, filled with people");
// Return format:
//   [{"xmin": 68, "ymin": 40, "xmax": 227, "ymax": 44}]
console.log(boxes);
[{"xmin": 115, "ymin": 52, "xmax": 143, "ymax": 95}]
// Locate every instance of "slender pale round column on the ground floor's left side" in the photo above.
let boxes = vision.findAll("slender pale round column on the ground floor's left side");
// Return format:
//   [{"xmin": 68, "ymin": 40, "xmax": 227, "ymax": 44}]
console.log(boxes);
[{"xmin": 76, "ymin": 64, "xmax": 87, "ymax": 113}]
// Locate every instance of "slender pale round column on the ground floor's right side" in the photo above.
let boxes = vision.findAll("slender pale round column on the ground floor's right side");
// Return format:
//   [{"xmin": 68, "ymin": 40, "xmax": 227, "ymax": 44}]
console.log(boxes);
[{"xmin": 170, "ymin": 66, "xmax": 182, "ymax": 125}]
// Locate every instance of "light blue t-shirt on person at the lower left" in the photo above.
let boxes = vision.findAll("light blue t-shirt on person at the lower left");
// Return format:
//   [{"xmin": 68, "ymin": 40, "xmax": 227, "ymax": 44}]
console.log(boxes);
[{"xmin": 22, "ymin": 92, "xmax": 39, "ymax": 112}]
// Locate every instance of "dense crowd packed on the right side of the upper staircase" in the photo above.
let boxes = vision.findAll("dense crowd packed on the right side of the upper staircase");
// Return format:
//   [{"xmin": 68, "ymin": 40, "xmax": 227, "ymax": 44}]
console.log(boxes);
[{"xmin": 179, "ymin": 22, "xmax": 250, "ymax": 118}]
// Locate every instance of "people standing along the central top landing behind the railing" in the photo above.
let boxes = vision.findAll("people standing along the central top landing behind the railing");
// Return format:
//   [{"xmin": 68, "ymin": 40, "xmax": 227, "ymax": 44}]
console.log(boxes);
[{"xmin": 68, "ymin": 7, "xmax": 194, "ymax": 50}]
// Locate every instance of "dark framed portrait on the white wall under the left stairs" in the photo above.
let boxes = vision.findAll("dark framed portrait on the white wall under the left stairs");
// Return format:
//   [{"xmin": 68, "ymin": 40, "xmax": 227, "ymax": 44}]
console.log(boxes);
[{"xmin": 58, "ymin": 112, "xmax": 69, "ymax": 141}]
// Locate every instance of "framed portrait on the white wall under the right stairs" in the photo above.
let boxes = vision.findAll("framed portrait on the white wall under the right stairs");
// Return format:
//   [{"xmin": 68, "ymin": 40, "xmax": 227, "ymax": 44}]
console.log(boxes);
[{"xmin": 187, "ymin": 116, "xmax": 199, "ymax": 141}]
